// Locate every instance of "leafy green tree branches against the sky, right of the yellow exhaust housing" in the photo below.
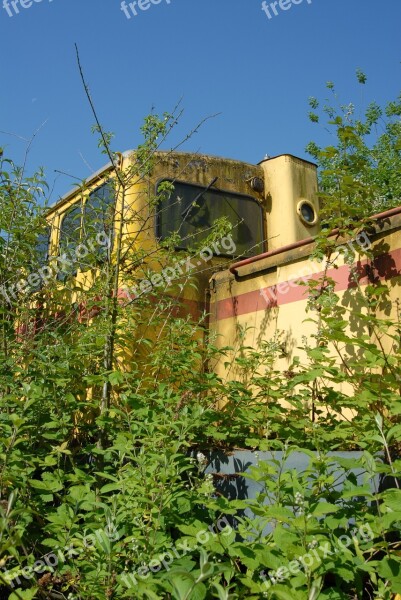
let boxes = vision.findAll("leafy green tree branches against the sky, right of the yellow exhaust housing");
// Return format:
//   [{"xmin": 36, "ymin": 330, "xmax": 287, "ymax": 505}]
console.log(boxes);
[{"xmin": 306, "ymin": 70, "xmax": 401, "ymax": 220}]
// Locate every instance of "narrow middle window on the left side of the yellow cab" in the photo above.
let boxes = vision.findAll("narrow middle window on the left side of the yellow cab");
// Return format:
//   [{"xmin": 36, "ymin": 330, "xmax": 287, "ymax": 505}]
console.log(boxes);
[{"xmin": 57, "ymin": 204, "xmax": 82, "ymax": 281}]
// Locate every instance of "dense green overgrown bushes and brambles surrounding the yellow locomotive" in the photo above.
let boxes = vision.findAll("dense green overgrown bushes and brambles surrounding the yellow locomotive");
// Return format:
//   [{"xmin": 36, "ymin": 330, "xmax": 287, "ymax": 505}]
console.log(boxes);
[{"xmin": 0, "ymin": 71, "xmax": 401, "ymax": 600}]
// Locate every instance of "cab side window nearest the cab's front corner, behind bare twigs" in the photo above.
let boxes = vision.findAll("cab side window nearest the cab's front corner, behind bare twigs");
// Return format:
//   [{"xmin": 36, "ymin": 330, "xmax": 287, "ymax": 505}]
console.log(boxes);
[{"xmin": 83, "ymin": 182, "xmax": 115, "ymax": 261}]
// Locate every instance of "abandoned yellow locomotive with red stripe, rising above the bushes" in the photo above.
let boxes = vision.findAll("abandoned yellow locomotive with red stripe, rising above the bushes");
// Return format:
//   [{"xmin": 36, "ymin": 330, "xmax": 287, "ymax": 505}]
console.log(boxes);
[{"xmin": 36, "ymin": 151, "xmax": 401, "ymax": 398}]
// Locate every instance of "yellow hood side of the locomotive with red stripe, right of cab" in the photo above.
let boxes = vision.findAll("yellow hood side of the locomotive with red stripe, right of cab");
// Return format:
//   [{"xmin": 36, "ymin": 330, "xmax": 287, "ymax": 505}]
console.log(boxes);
[{"xmin": 210, "ymin": 208, "xmax": 401, "ymax": 412}]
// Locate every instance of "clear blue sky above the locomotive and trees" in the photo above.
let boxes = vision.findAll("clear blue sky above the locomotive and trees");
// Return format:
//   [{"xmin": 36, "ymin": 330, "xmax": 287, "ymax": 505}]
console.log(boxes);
[{"xmin": 0, "ymin": 0, "xmax": 401, "ymax": 201}]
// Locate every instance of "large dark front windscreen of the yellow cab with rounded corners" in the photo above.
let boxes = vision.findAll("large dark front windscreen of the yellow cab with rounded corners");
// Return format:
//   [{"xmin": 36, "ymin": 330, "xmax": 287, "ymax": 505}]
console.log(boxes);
[{"xmin": 157, "ymin": 180, "xmax": 264, "ymax": 256}]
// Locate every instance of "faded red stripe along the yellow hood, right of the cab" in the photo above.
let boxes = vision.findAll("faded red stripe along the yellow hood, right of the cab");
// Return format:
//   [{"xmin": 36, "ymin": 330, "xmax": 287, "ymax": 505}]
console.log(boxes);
[{"xmin": 212, "ymin": 248, "xmax": 401, "ymax": 320}]
